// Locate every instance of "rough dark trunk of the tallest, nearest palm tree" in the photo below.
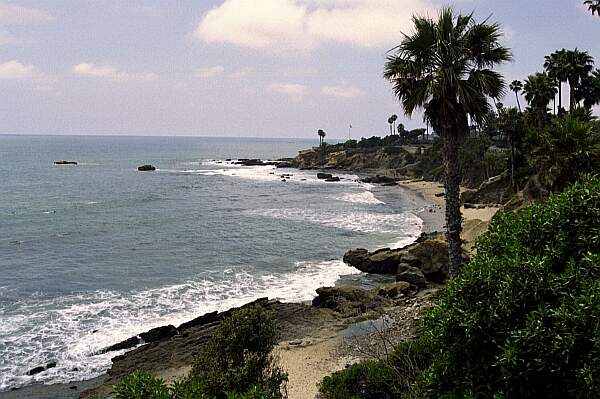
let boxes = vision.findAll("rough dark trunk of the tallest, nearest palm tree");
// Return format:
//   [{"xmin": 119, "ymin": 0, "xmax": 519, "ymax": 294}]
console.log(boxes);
[{"xmin": 444, "ymin": 134, "xmax": 462, "ymax": 278}]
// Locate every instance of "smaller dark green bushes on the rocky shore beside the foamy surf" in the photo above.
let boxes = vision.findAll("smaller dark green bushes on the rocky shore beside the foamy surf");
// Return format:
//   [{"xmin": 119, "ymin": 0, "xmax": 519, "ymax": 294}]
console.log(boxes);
[{"xmin": 114, "ymin": 306, "xmax": 287, "ymax": 399}]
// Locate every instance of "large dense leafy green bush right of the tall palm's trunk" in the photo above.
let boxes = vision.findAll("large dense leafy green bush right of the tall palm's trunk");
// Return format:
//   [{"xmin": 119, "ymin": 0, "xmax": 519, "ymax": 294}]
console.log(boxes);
[{"xmin": 417, "ymin": 177, "xmax": 600, "ymax": 398}]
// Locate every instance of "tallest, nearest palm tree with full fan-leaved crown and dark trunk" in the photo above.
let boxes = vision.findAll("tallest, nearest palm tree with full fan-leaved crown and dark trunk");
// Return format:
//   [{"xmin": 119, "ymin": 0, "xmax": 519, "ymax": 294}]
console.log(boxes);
[{"xmin": 384, "ymin": 8, "xmax": 512, "ymax": 277}]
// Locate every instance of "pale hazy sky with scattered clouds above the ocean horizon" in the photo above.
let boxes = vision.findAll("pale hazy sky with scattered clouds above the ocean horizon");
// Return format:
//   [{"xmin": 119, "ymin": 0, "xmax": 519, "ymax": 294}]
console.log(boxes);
[{"xmin": 0, "ymin": 0, "xmax": 600, "ymax": 138}]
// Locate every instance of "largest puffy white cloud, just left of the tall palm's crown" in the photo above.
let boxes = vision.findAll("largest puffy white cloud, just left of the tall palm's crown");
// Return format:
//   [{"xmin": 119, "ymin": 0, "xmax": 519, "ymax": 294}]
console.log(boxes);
[{"xmin": 193, "ymin": 0, "xmax": 435, "ymax": 50}]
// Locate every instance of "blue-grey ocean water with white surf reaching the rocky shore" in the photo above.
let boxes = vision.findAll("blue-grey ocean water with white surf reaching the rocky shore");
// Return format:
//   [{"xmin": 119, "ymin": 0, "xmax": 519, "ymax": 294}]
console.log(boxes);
[{"xmin": 0, "ymin": 136, "xmax": 422, "ymax": 391}]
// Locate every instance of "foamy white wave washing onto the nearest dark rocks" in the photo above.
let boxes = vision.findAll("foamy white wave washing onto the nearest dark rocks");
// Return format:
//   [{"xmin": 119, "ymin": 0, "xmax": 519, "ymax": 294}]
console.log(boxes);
[{"xmin": 0, "ymin": 260, "xmax": 359, "ymax": 391}]
